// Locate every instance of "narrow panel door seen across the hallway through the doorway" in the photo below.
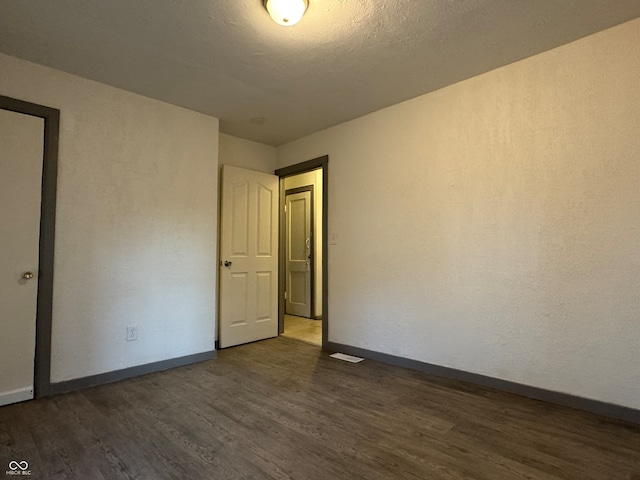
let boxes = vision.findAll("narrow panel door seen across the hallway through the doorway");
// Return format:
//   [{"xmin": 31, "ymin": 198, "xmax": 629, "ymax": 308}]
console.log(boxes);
[{"xmin": 285, "ymin": 191, "xmax": 311, "ymax": 318}]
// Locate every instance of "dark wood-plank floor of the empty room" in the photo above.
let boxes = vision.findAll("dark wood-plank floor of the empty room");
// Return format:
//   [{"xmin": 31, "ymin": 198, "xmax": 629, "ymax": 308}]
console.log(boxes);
[{"xmin": 0, "ymin": 337, "xmax": 640, "ymax": 480}]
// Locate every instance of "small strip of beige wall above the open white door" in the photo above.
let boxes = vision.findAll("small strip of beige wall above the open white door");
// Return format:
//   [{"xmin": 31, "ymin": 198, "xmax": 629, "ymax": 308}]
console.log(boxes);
[{"xmin": 219, "ymin": 133, "xmax": 276, "ymax": 173}]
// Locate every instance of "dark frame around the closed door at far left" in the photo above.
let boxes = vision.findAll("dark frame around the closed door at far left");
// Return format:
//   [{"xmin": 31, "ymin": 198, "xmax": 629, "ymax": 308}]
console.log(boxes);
[{"xmin": 0, "ymin": 95, "xmax": 60, "ymax": 398}]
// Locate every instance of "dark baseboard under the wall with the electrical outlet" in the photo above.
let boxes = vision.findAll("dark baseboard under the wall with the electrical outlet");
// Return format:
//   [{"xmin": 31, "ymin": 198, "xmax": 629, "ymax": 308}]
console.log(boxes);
[{"xmin": 48, "ymin": 350, "xmax": 217, "ymax": 395}]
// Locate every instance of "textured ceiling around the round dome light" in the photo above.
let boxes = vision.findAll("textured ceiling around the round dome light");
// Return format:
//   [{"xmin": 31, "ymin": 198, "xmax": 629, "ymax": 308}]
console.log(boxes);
[{"xmin": 0, "ymin": 0, "xmax": 640, "ymax": 145}]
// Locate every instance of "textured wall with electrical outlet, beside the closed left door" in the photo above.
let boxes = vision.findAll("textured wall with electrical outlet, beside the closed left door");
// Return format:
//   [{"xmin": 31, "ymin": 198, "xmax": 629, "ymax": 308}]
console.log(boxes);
[{"xmin": 0, "ymin": 55, "xmax": 218, "ymax": 382}]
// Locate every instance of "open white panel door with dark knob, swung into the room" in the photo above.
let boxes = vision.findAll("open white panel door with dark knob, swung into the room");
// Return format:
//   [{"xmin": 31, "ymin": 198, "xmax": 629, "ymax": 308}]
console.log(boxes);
[{"xmin": 219, "ymin": 165, "xmax": 279, "ymax": 348}]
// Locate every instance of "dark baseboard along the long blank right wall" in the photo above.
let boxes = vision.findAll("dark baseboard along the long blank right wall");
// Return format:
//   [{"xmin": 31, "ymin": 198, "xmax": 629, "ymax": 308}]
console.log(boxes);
[{"xmin": 326, "ymin": 342, "xmax": 640, "ymax": 424}]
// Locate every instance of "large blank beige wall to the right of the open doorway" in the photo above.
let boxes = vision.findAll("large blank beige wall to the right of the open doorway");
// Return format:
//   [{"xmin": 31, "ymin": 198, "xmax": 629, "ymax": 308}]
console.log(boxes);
[{"xmin": 278, "ymin": 19, "xmax": 640, "ymax": 408}]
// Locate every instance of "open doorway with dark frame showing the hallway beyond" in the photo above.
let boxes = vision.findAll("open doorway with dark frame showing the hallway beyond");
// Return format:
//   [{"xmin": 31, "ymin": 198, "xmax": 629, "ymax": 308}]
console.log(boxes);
[{"xmin": 275, "ymin": 156, "xmax": 329, "ymax": 348}]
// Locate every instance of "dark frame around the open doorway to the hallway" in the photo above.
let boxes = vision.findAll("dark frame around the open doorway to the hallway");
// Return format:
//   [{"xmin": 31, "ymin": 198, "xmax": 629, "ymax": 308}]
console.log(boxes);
[{"xmin": 275, "ymin": 155, "xmax": 329, "ymax": 350}]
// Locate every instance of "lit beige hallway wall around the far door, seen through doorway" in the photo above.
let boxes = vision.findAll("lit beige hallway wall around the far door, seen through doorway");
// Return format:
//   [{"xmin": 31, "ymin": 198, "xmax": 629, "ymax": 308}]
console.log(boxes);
[{"xmin": 284, "ymin": 170, "xmax": 322, "ymax": 317}]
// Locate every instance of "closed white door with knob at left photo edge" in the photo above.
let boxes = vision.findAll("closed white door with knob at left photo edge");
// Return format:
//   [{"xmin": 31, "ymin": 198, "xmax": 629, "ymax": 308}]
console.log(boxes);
[{"xmin": 0, "ymin": 109, "xmax": 44, "ymax": 405}]
